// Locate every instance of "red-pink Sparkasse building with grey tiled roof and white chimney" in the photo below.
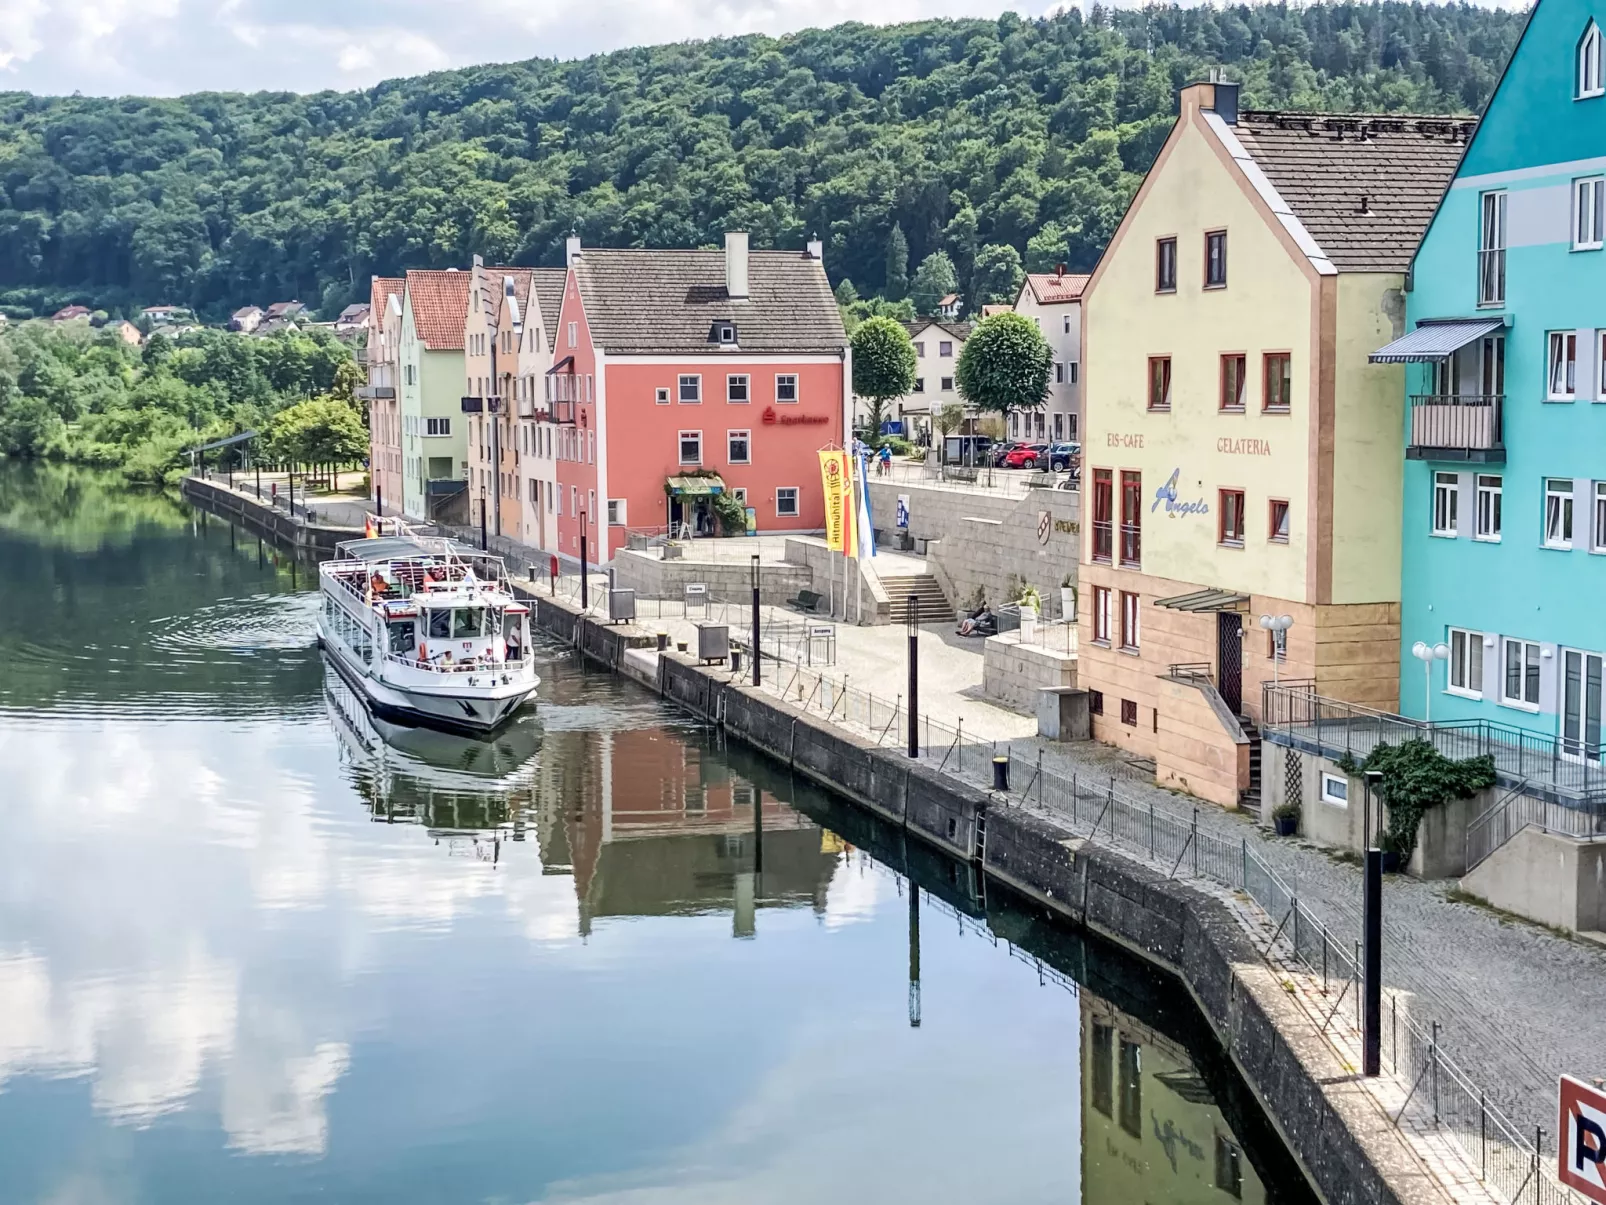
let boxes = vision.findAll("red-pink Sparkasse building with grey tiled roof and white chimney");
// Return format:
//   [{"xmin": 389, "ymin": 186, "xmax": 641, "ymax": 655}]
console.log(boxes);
[{"xmin": 541, "ymin": 233, "xmax": 853, "ymax": 564}]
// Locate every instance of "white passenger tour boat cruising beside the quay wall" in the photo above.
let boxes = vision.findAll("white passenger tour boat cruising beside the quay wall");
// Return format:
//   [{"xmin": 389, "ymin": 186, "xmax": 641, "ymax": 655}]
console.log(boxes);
[{"xmin": 318, "ymin": 519, "xmax": 540, "ymax": 733}]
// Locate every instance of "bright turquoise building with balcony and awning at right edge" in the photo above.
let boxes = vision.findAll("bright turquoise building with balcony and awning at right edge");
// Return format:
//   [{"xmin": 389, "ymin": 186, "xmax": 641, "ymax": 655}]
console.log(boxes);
[{"xmin": 1373, "ymin": 0, "xmax": 1606, "ymax": 774}]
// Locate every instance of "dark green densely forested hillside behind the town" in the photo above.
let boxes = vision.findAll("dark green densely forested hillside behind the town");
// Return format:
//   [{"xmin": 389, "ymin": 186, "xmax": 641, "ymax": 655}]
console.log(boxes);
[{"xmin": 0, "ymin": 3, "xmax": 1524, "ymax": 315}]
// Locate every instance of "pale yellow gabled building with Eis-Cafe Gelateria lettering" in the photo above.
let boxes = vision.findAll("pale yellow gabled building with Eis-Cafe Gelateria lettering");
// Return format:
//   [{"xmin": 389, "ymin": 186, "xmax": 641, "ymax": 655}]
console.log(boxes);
[{"xmin": 1079, "ymin": 84, "xmax": 1466, "ymax": 807}]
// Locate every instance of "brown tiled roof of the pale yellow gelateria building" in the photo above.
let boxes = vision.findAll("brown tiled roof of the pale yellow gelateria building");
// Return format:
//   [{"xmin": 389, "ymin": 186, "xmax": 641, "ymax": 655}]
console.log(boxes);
[{"xmin": 1227, "ymin": 111, "xmax": 1478, "ymax": 272}]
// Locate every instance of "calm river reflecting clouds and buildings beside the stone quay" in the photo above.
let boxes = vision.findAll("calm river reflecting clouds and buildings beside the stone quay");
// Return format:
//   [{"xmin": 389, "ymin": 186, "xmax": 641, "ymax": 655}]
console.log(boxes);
[{"xmin": 0, "ymin": 463, "xmax": 1310, "ymax": 1205}]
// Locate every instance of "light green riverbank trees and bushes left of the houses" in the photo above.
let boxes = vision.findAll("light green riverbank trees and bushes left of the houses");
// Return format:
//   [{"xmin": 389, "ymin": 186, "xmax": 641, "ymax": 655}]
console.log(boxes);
[{"xmin": 0, "ymin": 321, "xmax": 366, "ymax": 482}]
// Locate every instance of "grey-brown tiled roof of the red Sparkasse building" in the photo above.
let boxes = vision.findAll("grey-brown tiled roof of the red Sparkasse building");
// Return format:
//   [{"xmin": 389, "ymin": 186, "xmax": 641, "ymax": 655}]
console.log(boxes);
[{"xmin": 575, "ymin": 247, "xmax": 848, "ymax": 355}]
